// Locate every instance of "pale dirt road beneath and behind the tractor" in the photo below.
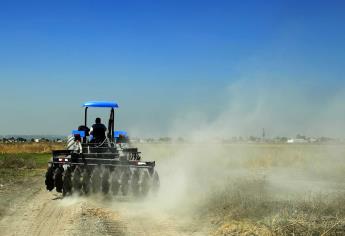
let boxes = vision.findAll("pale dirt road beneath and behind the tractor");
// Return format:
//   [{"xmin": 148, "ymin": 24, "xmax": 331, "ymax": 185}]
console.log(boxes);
[{"xmin": 0, "ymin": 175, "xmax": 208, "ymax": 236}]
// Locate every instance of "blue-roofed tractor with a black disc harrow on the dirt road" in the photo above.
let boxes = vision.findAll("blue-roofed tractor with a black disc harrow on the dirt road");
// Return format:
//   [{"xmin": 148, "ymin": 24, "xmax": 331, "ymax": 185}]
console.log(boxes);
[{"xmin": 45, "ymin": 102, "xmax": 160, "ymax": 196}]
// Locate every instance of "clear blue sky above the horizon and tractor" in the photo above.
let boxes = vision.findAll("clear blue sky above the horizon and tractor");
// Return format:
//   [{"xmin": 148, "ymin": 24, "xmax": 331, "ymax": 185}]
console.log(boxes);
[{"xmin": 0, "ymin": 0, "xmax": 345, "ymax": 136}]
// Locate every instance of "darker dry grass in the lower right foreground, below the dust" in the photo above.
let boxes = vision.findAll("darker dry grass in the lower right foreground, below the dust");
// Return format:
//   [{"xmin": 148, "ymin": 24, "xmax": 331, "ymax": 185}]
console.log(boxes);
[{"xmin": 206, "ymin": 180, "xmax": 345, "ymax": 236}]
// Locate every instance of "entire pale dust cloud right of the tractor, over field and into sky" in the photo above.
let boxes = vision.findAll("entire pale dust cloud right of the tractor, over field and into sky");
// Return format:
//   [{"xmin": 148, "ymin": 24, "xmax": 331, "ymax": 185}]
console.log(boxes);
[{"xmin": 136, "ymin": 79, "xmax": 345, "ymax": 223}]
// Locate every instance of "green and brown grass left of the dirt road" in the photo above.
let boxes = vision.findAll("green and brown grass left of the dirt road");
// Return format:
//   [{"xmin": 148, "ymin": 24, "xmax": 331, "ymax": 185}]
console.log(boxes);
[{"xmin": 0, "ymin": 143, "xmax": 63, "ymax": 217}]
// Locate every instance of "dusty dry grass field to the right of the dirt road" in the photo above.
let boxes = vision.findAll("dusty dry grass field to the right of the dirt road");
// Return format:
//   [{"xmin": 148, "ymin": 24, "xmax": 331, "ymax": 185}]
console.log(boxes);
[{"xmin": 141, "ymin": 144, "xmax": 345, "ymax": 236}]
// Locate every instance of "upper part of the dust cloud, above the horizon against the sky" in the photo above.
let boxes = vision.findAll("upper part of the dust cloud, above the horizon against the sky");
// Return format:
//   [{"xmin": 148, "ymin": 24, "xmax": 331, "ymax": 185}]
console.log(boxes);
[{"xmin": 169, "ymin": 78, "xmax": 345, "ymax": 138}]
